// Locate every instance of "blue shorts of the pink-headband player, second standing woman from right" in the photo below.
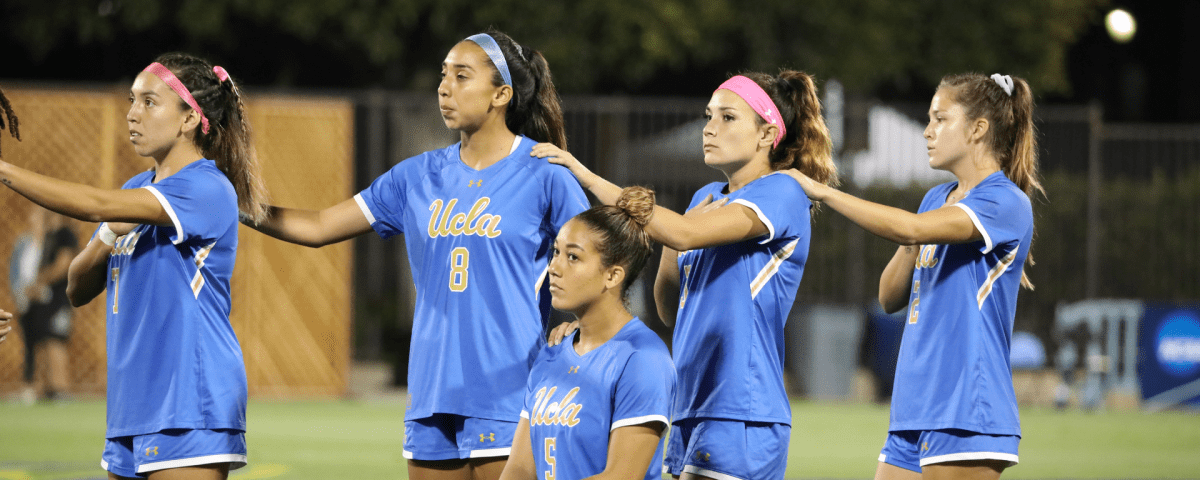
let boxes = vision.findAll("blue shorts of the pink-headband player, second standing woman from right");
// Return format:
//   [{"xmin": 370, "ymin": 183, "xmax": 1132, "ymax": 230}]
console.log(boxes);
[{"xmin": 664, "ymin": 419, "xmax": 792, "ymax": 480}]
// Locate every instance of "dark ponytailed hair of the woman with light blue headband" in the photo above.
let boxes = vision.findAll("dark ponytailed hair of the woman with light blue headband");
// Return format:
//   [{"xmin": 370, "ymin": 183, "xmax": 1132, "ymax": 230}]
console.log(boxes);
[{"xmin": 475, "ymin": 29, "xmax": 566, "ymax": 150}]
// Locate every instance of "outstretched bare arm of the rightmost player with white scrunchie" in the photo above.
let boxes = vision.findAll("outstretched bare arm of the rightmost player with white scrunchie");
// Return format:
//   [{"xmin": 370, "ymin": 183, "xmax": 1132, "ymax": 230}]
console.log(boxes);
[{"xmin": 784, "ymin": 169, "xmax": 983, "ymax": 245}]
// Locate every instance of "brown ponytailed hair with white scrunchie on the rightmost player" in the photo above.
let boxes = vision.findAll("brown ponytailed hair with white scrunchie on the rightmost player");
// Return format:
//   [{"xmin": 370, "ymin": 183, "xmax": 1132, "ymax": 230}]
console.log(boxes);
[{"xmin": 937, "ymin": 73, "xmax": 1046, "ymax": 290}]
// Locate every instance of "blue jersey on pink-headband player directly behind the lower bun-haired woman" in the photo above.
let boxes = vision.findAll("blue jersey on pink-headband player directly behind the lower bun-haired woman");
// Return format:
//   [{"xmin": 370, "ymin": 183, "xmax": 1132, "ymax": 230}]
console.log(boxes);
[{"xmin": 674, "ymin": 173, "xmax": 812, "ymax": 424}]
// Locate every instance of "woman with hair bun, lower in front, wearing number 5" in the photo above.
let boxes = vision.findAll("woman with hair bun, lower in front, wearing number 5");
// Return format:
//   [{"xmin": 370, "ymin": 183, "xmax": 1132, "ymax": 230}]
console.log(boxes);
[{"xmin": 500, "ymin": 187, "xmax": 674, "ymax": 480}]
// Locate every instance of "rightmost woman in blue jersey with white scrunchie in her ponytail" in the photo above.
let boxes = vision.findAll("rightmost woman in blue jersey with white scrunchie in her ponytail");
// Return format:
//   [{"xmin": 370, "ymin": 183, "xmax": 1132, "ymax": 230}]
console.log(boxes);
[{"xmin": 791, "ymin": 73, "xmax": 1045, "ymax": 479}]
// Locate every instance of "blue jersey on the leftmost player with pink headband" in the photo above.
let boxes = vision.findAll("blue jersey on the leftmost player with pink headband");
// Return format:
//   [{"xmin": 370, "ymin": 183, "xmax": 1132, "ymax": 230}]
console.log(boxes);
[{"xmin": 106, "ymin": 160, "xmax": 246, "ymax": 438}]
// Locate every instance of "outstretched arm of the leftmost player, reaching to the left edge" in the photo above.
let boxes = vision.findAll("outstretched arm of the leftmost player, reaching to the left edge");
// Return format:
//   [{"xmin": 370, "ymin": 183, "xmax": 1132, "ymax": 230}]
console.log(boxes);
[{"xmin": 0, "ymin": 160, "xmax": 172, "ymax": 226}]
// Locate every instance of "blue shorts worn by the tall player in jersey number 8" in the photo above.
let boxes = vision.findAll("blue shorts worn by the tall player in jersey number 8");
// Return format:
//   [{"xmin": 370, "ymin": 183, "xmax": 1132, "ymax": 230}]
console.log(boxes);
[{"xmin": 404, "ymin": 413, "xmax": 517, "ymax": 461}]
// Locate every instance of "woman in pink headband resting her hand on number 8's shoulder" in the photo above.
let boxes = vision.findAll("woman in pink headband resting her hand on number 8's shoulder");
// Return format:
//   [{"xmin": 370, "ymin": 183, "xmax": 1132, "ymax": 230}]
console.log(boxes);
[{"xmin": 534, "ymin": 71, "xmax": 836, "ymax": 479}]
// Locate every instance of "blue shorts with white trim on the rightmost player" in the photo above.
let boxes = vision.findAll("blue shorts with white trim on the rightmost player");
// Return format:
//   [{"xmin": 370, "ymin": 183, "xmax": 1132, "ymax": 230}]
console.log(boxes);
[{"xmin": 880, "ymin": 428, "xmax": 1021, "ymax": 473}]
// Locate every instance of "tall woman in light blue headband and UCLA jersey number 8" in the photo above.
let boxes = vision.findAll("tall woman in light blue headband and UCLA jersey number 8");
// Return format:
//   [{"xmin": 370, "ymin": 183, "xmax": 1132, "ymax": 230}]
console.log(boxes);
[{"xmin": 237, "ymin": 31, "xmax": 588, "ymax": 480}]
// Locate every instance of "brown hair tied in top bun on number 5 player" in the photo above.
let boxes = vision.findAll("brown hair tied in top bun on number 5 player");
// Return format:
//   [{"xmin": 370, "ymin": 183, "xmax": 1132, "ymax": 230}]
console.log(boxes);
[{"xmin": 575, "ymin": 186, "xmax": 654, "ymax": 298}]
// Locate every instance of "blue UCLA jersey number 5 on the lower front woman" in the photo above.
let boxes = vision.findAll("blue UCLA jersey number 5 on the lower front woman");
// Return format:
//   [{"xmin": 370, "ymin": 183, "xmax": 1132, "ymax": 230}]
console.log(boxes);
[{"xmin": 521, "ymin": 317, "xmax": 676, "ymax": 480}]
